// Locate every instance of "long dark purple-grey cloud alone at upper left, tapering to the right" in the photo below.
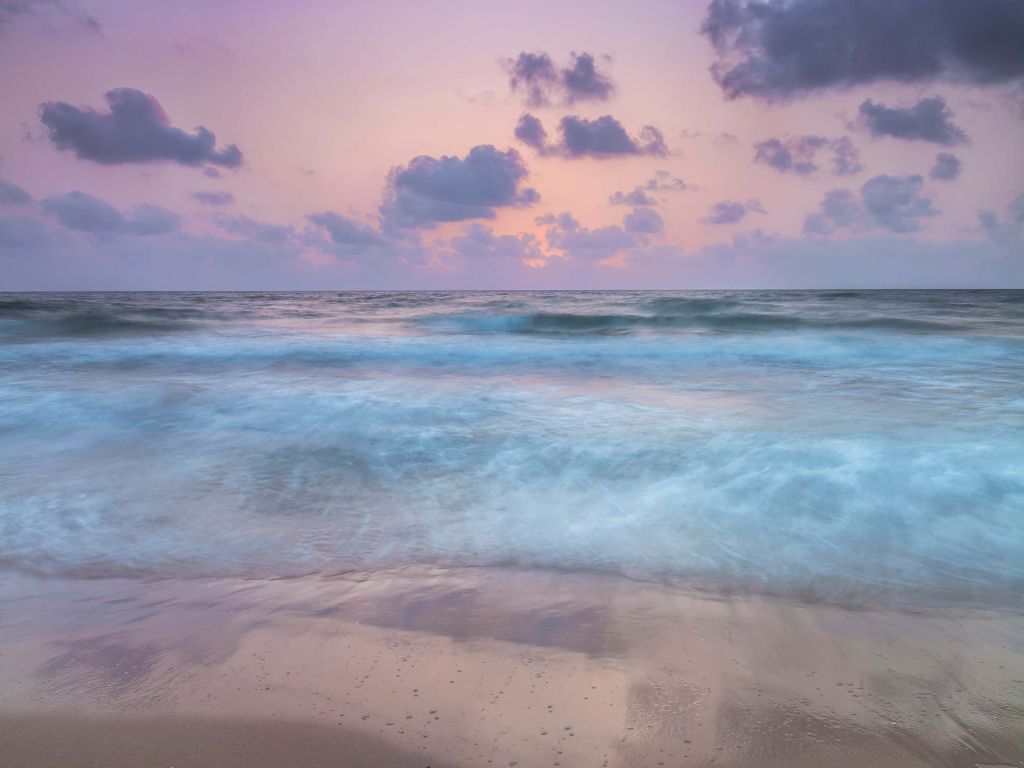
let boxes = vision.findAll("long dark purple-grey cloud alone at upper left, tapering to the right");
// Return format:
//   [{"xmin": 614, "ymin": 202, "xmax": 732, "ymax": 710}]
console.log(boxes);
[{"xmin": 40, "ymin": 88, "xmax": 242, "ymax": 168}]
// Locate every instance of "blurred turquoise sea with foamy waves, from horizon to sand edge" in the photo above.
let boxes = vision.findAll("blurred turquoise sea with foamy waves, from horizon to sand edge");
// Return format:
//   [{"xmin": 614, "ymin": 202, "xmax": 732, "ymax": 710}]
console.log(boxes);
[{"xmin": 0, "ymin": 291, "xmax": 1024, "ymax": 607}]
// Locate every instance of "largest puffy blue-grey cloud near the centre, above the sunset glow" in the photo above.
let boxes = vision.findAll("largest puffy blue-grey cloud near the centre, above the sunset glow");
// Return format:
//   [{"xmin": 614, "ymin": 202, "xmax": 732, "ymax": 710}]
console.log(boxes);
[{"xmin": 381, "ymin": 144, "xmax": 540, "ymax": 228}]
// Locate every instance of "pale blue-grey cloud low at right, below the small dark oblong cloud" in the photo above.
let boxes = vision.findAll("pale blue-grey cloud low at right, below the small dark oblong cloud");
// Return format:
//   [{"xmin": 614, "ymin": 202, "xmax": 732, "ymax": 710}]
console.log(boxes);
[{"xmin": 804, "ymin": 175, "xmax": 938, "ymax": 234}]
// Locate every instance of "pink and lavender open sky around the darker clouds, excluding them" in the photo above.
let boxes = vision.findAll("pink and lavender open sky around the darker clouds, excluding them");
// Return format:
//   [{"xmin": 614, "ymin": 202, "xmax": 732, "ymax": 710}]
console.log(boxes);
[{"xmin": 0, "ymin": 0, "xmax": 1024, "ymax": 290}]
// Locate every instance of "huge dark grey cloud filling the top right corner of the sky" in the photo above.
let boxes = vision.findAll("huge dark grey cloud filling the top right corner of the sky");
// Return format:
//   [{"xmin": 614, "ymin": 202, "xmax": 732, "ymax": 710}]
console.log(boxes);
[{"xmin": 701, "ymin": 0, "xmax": 1024, "ymax": 99}]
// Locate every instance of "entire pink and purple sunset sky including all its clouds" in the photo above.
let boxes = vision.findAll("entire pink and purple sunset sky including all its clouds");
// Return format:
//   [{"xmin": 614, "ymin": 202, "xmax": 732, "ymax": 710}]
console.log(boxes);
[{"xmin": 0, "ymin": 0, "xmax": 1024, "ymax": 291}]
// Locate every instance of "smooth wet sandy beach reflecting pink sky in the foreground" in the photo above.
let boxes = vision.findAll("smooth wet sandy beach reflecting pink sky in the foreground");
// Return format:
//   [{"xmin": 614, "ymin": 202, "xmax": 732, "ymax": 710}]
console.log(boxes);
[{"xmin": 0, "ymin": 568, "xmax": 1024, "ymax": 768}]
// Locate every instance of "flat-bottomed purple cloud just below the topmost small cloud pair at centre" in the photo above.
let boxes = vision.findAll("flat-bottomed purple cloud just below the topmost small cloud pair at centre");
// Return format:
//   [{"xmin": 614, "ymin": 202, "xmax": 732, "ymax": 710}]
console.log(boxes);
[{"xmin": 515, "ymin": 114, "xmax": 669, "ymax": 159}]
